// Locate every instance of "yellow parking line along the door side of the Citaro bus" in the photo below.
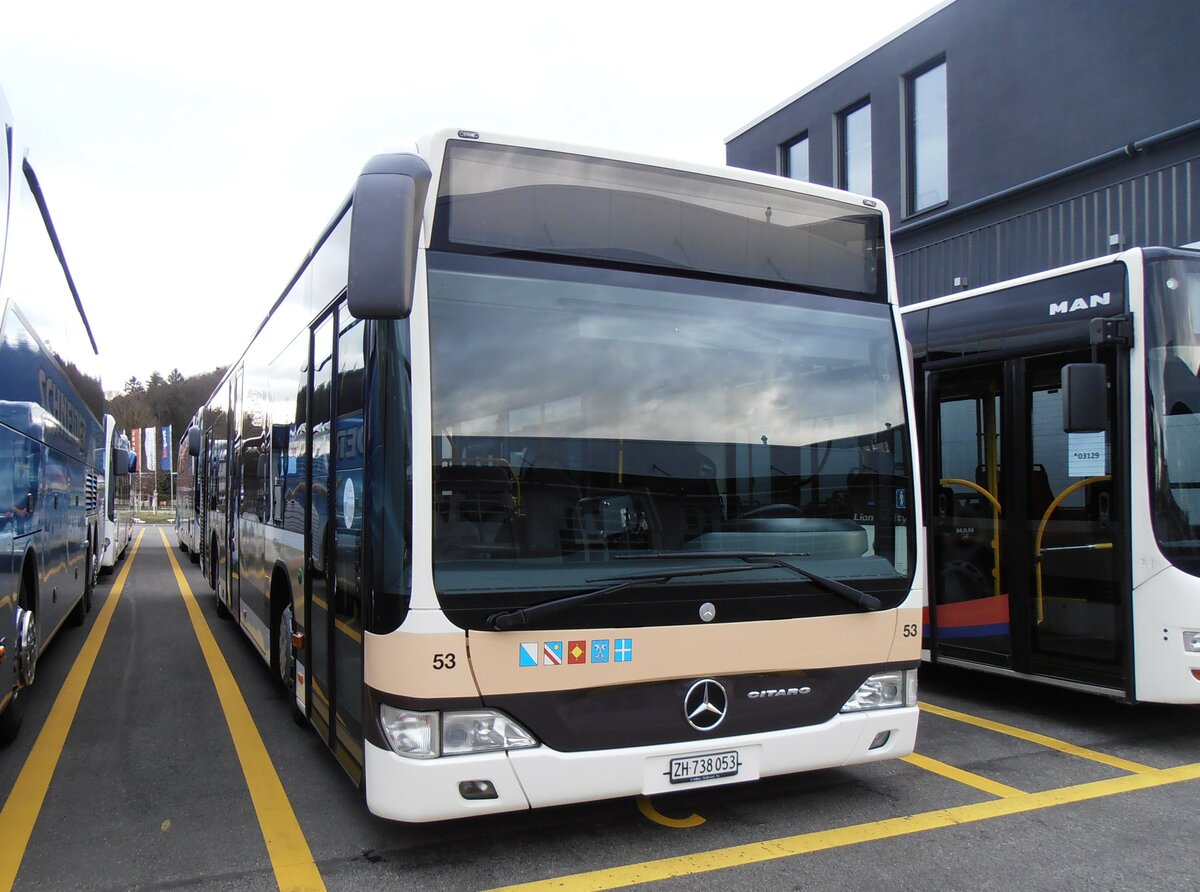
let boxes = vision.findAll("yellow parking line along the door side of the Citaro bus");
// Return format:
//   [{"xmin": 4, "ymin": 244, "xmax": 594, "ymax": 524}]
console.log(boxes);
[{"xmin": 158, "ymin": 529, "xmax": 325, "ymax": 890}]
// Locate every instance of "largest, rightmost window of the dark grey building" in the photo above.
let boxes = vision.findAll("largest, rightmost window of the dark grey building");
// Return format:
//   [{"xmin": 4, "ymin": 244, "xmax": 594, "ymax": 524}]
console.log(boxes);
[{"xmin": 906, "ymin": 61, "xmax": 949, "ymax": 214}]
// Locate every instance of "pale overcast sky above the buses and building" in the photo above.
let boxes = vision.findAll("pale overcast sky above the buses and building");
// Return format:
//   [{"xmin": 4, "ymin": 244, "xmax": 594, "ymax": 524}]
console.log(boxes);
[{"xmin": 0, "ymin": 0, "xmax": 941, "ymax": 391}]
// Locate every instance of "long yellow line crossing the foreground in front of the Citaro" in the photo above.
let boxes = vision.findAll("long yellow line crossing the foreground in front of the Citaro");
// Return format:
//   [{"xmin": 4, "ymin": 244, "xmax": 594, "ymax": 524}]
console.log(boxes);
[{"xmin": 492, "ymin": 764, "xmax": 1200, "ymax": 892}]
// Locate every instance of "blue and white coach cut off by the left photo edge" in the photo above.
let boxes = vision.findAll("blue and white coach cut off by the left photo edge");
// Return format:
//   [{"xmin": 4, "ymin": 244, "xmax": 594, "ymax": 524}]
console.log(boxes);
[{"xmin": 0, "ymin": 92, "xmax": 104, "ymax": 742}]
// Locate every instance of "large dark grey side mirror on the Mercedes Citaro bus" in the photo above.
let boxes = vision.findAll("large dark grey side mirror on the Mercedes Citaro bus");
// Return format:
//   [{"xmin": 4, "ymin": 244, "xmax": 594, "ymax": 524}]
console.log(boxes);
[{"xmin": 346, "ymin": 155, "xmax": 433, "ymax": 319}]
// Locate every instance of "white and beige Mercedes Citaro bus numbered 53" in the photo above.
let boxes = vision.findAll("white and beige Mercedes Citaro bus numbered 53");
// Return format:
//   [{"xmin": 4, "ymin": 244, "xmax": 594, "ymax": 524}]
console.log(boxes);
[{"xmin": 190, "ymin": 131, "xmax": 923, "ymax": 821}]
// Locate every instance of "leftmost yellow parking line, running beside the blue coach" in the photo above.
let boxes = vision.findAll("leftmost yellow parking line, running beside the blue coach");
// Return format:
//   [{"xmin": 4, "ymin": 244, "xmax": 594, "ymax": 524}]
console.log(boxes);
[{"xmin": 0, "ymin": 529, "xmax": 145, "ymax": 890}]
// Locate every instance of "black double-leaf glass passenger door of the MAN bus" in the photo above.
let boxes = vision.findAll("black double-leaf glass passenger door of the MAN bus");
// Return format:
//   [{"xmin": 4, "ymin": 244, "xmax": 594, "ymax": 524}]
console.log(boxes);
[{"xmin": 926, "ymin": 346, "xmax": 1129, "ymax": 692}]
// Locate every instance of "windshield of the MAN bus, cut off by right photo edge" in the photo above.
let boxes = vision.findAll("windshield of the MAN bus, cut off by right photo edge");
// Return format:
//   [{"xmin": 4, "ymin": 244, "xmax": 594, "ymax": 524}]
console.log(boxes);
[{"xmin": 1146, "ymin": 257, "xmax": 1200, "ymax": 575}]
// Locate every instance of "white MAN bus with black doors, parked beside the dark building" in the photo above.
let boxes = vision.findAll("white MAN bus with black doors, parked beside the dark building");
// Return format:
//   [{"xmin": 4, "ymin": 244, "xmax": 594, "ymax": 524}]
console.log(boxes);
[{"xmin": 904, "ymin": 249, "xmax": 1200, "ymax": 704}]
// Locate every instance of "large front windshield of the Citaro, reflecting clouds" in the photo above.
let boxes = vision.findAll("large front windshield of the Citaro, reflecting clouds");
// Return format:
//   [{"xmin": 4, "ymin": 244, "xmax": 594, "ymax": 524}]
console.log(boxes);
[{"xmin": 427, "ymin": 252, "xmax": 914, "ymax": 628}]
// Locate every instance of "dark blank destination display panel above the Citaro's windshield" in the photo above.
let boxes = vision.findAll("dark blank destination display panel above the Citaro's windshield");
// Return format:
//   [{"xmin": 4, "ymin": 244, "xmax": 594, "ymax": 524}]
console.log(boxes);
[{"xmin": 432, "ymin": 140, "xmax": 888, "ymax": 303}]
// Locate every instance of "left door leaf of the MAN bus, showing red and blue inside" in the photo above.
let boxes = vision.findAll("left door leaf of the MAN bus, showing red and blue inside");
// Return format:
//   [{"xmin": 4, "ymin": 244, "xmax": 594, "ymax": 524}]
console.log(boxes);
[{"xmin": 926, "ymin": 365, "xmax": 1013, "ymax": 667}]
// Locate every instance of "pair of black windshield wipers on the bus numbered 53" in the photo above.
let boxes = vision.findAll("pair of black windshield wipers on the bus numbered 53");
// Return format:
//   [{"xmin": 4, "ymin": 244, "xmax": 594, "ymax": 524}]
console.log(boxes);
[{"xmin": 487, "ymin": 551, "xmax": 883, "ymax": 631}]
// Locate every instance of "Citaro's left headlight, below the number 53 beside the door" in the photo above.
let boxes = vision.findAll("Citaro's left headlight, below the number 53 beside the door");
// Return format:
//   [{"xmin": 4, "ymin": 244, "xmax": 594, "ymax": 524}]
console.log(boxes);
[{"xmin": 379, "ymin": 705, "xmax": 538, "ymax": 759}]
